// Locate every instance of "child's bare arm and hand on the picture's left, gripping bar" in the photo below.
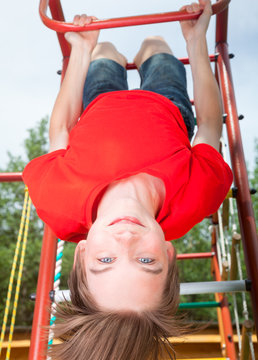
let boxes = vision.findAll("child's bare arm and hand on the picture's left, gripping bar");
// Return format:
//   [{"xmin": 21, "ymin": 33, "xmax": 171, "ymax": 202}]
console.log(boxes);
[{"xmin": 49, "ymin": 15, "xmax": 99, "ymax": 152}]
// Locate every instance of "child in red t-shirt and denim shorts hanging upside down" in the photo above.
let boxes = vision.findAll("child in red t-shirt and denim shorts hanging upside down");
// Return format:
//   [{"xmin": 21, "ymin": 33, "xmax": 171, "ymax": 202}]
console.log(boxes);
[{"xmin": 23, "ymin": 0, "xmax": 232, "ymax": 360}]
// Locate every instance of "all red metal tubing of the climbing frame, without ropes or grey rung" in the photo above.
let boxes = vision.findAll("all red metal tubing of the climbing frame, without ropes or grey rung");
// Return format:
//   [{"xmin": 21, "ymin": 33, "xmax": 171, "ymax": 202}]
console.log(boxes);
[{"xmin": 0, "ymin": 0, "xmax": 258, "ymax": 360}]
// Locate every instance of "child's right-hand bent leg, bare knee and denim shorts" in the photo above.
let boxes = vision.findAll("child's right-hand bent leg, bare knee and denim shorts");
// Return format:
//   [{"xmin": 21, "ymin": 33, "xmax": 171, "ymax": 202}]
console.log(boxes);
[{"xmin": 134, "ymin": 36, "xmax": 194, "ymax": 139}]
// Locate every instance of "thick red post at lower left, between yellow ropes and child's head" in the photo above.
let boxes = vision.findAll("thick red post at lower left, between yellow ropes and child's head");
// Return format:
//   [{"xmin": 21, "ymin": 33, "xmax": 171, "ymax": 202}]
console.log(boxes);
[{"xmin": 29, "ymin": 226, "xmax": 57, "ymax": 360}]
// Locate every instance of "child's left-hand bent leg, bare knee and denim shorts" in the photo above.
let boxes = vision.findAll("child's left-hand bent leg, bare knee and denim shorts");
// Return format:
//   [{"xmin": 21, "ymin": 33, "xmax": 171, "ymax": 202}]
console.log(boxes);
[{"xmin": 83, "ymin": 42, "xmax": 128, "ymax": 109}]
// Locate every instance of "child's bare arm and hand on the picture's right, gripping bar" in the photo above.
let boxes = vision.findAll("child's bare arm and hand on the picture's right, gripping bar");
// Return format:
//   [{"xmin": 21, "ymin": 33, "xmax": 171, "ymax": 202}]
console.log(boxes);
[{"xmin": 181, "ymin": 0, "xmax": 222, "ymax": 150}]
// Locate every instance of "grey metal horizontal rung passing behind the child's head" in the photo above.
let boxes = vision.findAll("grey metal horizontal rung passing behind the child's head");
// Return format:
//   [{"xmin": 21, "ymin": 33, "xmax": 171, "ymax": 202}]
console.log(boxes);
[{"xmin": 54, "ymin": 280, "xmax": 249, "ymax": 302}]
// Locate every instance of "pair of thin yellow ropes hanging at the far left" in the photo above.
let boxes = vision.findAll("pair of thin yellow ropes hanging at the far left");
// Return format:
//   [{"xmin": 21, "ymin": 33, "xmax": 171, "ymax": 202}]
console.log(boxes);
[{"xmin": 0, "ymin": 188, "xmax": 31, "ymax": 359}]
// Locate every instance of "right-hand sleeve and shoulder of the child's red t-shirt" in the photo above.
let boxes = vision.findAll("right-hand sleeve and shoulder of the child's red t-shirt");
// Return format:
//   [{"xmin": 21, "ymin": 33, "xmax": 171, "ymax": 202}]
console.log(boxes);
[{"xmin": 165, "ymin": 144, "xmax": 233, "ymax": 240}]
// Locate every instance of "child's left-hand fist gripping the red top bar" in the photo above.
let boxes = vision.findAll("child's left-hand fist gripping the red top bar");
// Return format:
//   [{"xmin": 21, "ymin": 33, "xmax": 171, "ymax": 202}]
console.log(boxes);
[{"xmin": 65, "ymin": 14, "xmax": 99, "ymax": 53}]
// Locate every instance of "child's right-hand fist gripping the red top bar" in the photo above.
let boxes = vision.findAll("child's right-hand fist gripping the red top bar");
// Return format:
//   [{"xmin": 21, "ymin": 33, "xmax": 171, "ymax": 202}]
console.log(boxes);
[{"xmin": 180, "ymin": 0, "xmax": 212, "ymax": 42}]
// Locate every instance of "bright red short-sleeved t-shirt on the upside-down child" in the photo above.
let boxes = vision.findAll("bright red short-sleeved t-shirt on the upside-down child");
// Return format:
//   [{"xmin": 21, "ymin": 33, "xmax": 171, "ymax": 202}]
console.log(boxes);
[{"xmin": 23, "ymin": 90, "xmax": 232, "ymax": 242}]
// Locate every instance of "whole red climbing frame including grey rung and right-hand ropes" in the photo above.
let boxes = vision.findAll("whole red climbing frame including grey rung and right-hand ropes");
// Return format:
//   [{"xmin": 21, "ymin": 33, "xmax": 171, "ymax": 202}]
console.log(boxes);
[{"xmin": 0, "ymin": 0, "xmax": 258, "ymax": 360}]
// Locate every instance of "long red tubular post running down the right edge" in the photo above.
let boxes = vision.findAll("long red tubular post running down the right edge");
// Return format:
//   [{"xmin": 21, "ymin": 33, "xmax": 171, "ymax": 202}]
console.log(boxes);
[{"xmin": 217, "ymin": 43, "xmax": 258, "ymax": 331}]
